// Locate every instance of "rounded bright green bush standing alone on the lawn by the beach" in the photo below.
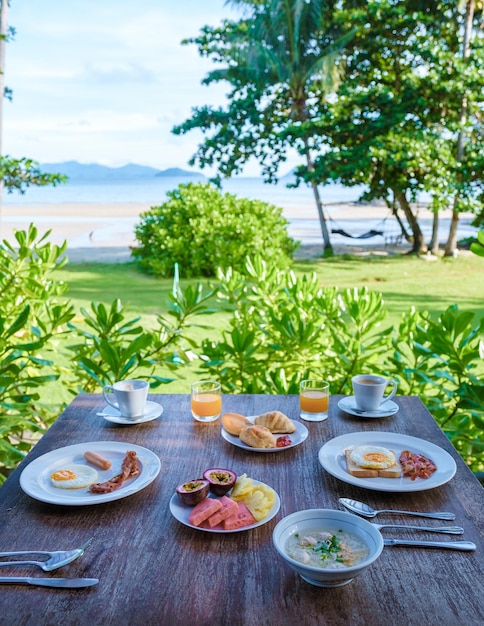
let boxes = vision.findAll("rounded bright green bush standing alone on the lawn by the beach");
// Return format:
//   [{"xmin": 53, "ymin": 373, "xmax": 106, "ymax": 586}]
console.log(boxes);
[{"xmin": 133, "ymin": 184, "xmax": 297, "ymax": 277}]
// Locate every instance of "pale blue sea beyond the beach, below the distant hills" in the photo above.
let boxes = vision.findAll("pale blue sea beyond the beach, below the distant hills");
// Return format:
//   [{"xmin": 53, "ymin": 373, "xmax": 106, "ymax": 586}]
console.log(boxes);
[{"xmin": 2, "ymin": 176, "xmax": 477, "ymax": 248}]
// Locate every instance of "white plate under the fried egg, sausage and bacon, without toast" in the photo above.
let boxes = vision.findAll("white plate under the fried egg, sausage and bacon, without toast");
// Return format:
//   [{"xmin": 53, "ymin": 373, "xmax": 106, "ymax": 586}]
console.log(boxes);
[{"xmin": 20, "ymin": 441, "xmax": 161, "ymax": 506}]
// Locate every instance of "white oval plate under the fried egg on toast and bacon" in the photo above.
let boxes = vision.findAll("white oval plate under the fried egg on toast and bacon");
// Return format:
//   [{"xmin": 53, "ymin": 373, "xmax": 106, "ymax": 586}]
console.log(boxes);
[{"xmin": 318, "ymin": 432, "xmax": 456, "ymax": 492}]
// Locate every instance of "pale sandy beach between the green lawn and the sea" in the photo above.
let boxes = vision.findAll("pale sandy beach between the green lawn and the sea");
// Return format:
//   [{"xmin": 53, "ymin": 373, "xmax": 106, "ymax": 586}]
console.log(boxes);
[{"xmin": 0, "ymin": 202, "xmax": 472, "ymax": 262}]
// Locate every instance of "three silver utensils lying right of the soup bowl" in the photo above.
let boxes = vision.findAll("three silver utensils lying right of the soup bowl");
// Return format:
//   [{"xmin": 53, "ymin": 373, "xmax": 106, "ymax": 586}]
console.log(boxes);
[{"xmin": 339, "ymin": 498, "xmax": 476, "ymax": 551}]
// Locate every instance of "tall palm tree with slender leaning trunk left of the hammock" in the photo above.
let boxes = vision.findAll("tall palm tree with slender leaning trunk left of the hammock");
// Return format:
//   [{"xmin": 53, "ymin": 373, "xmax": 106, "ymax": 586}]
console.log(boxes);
[{"xmin": 224, "ymin": 0, "xmax": 354, "ymax": 253}]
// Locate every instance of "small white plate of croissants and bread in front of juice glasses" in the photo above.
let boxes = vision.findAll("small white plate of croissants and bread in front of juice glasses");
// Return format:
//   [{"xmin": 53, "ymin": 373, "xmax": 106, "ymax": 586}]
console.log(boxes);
[{"xmin": 221, "ymin": 411, "xmax": 309, "ymax": 452}]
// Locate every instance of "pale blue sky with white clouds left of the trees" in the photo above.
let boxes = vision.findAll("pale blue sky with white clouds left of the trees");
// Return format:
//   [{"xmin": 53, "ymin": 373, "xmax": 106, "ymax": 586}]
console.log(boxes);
[{"xmin": 3, "ymin": 0, "xmax": 282, "ymax": 176}]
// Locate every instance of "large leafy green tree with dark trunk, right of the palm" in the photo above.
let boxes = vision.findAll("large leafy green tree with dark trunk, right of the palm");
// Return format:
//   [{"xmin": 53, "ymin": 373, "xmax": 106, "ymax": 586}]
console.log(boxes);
[{"xmin": 299, "ymin": 0, "xmax": 483, "ymax": 252}]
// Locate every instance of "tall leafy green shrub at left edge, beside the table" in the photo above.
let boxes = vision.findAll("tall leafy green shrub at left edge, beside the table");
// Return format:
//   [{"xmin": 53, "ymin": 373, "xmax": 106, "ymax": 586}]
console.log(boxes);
[{"xmin": 0, "ymin": 225, "xmax": 74, "ymax": 484}]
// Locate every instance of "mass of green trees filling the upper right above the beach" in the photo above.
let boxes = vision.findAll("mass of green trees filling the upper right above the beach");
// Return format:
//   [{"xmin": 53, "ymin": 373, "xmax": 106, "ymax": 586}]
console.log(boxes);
[{"xmin": 174, "ymin": 0, "xmax": 484, "ymax": 252}]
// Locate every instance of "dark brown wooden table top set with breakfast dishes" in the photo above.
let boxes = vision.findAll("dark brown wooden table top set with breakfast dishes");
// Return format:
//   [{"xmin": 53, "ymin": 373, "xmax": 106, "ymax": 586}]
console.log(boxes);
[{"xmin": 0, "ymin": 394, "xmax": 484, "ymax": 626}]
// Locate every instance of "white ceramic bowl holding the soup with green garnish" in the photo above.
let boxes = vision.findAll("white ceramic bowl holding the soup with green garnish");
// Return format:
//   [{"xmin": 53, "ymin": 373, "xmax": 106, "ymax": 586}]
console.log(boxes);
[{"xmin": 272, "ymin": 509, "xmax": 383, "ymax": 587}]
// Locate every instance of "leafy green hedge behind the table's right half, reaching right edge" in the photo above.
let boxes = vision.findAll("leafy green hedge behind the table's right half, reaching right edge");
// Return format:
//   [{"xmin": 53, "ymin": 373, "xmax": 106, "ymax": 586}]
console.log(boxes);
[{"xmin": 199, "ymin": 259, "xmax": 484, "ymax": 472}]
